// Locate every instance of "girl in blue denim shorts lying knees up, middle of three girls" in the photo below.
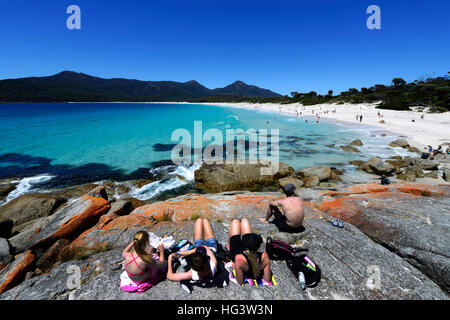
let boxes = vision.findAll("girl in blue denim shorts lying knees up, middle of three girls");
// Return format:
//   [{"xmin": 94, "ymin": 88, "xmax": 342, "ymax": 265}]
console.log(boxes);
[{"xmin": 167, "ymin": 218, "xmax": 217, "ymax": 281}]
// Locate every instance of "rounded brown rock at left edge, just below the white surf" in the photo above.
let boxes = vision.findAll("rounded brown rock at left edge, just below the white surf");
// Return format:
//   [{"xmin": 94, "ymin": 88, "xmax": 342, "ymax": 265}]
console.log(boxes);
[{"xmin": 0, "ymin": 193, "xmax": 67, "ymax": 225}]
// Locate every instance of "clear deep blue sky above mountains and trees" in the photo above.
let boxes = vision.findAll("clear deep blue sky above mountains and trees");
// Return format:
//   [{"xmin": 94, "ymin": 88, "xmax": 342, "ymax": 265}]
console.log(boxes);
[{"xmin": 0, "ymin": 0, "xmax": 450, "ymax": 94}]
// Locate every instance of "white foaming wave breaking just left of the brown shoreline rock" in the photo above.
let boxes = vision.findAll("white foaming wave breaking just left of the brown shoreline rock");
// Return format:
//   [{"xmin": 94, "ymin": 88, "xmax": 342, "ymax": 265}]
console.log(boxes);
[{"xmin": 125, "ymin": 163, "xmax": 201, "ymax": 200}]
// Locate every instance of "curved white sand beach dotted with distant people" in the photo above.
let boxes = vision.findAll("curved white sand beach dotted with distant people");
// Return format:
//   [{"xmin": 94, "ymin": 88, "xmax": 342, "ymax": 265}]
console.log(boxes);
[{"xmin": 205, "ymin": 103, "xmax": 450, "ymax": 150}]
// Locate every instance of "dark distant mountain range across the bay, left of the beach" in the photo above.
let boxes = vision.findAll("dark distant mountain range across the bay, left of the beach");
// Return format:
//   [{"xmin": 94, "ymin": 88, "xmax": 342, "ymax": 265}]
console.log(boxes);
[{"xmin": 0, "ymin": 71, "xmax": 280, "ymax": 102}]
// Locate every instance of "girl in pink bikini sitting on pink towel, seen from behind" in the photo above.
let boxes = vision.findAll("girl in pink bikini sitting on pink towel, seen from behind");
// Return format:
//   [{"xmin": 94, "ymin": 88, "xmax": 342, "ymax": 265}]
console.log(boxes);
[{"xmin": 120, "ymin": 231, "xmax": 167, "ymax": 292}]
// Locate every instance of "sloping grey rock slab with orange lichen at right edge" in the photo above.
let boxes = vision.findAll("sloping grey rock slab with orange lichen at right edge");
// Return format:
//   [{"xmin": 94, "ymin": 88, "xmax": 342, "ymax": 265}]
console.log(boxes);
[{"xmin": 319, "ymin": 184, "xmax": 450, "ymax": 292}]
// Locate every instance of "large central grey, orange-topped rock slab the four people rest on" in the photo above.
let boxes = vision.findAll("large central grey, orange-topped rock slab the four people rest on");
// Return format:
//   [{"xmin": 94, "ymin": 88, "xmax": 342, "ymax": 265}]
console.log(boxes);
[{"xmin": 0, "ymin": 193, "xmax": 448, "ymax": 300}]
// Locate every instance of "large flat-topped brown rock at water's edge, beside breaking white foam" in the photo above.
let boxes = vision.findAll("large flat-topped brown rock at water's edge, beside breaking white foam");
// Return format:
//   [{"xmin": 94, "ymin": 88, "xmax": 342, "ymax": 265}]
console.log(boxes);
[{"xmin": 195, "ymin": 162, "xmax": 294, "ymax": 192}]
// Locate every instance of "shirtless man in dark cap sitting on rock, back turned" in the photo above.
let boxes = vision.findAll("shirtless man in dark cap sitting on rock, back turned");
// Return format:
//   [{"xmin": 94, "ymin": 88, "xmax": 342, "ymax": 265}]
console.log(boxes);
[{"xmin": 260, "ymin": 184, "xmax": 305, "ymax": 233}]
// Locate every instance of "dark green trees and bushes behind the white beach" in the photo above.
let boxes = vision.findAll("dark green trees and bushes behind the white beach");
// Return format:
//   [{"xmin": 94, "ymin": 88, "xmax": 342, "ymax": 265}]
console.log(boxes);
[{"xmin": 190, "ymin": 72, "xmax": 450, "ymax": 112}]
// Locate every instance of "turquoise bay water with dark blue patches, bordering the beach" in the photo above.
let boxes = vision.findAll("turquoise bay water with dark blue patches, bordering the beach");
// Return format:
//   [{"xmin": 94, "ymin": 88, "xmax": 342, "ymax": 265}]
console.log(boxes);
[{"xmin": 0, "ymin": 103, "xmax": 414, "ymax": 200}]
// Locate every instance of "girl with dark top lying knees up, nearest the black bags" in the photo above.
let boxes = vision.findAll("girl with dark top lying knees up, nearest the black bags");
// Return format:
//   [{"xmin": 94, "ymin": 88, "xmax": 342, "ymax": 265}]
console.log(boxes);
[{"xmin": 227, "ymin": 218, "xmax": 272, "ymax": 285}]
